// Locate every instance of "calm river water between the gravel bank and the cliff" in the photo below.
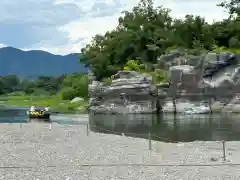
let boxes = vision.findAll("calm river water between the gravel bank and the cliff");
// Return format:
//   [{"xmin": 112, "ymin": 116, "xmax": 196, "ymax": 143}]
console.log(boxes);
[{"xmin": 0, "ymin": 108, "xmax": 240, "ymax": 142}]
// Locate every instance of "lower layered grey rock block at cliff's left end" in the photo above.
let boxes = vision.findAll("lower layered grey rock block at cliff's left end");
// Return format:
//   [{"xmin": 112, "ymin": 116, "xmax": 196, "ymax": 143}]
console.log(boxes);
[{"xmin": 89, "ymin": 71, "xmax": 156, "ymax": 114}]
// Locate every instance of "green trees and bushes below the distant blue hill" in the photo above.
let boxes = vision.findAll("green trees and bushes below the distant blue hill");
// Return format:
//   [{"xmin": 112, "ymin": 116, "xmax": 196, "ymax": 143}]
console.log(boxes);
[{"xmin": 0, "ymin": 73, "xmax": 88, "ymax": 100}]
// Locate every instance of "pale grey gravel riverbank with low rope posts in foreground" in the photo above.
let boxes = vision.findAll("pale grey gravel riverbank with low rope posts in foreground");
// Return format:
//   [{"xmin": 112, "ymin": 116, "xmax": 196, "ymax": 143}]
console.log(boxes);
[{"xmin": 0, "ymin": 123, "xmax": 240, "ymax": 180}]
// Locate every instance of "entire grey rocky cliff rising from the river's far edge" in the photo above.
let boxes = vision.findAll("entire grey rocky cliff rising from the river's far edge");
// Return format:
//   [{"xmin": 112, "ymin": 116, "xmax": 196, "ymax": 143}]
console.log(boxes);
[{"xmin": 89, "ymin": 52, "xmax": 240, "ymax": 114}]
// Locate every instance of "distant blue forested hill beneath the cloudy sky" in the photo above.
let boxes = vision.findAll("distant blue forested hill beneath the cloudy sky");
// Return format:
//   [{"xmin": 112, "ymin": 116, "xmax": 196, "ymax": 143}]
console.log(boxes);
[{"xmin": 0, "ymin": 47, "xmax": 87, "ymax": 78}]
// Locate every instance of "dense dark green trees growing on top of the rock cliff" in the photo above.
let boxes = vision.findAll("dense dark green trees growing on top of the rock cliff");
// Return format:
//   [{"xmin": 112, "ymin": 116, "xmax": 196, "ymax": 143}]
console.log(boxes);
[{"xmin": 80, "ymin": 0, "xmax": 240, "ymax": 80}]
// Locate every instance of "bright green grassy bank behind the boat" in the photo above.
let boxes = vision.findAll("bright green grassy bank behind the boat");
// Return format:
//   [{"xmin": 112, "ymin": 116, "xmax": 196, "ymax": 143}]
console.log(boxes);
[{"xmin": 0, "ymin": 95, "xmax": 87, "ymax": 113}]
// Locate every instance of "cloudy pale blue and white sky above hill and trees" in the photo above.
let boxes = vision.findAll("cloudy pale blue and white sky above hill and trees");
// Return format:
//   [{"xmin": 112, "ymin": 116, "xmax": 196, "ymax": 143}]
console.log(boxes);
[{"xmin": 0, "ymin": 0, "xmax": 227, "ymax": 55}]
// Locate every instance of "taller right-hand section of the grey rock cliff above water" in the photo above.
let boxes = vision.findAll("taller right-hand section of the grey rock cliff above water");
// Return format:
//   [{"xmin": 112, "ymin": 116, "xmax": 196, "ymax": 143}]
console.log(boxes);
[{"xmin": 164, "ymin": 53, "xmax": 240, "ymax": 111}]
